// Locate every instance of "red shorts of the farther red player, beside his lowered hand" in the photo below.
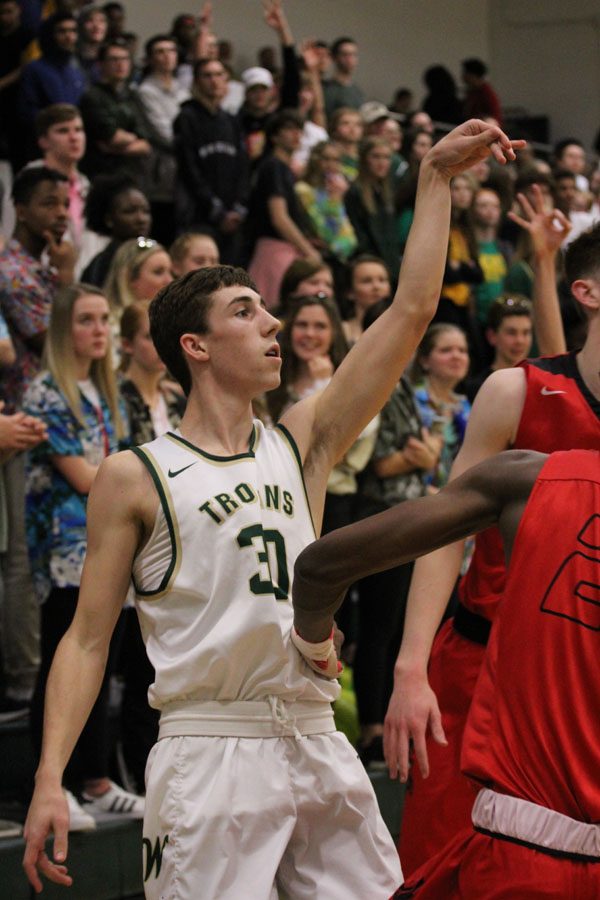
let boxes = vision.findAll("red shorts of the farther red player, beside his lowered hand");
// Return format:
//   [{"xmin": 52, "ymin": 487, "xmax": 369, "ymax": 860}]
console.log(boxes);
[{"xmin": 398, "ymin": 620, "xmax": 485, "ymax": 877}]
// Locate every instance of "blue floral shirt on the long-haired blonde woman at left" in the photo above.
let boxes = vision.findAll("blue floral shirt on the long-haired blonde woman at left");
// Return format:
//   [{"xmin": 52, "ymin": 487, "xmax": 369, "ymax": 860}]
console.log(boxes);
[{"xmin": 24, "ymin": 372, "xmax": 126, "ymax": 602}]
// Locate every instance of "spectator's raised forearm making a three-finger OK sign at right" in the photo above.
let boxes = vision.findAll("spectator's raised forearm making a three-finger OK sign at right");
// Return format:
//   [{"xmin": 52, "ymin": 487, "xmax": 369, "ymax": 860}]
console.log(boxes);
[{"xmin": 508, "ymin": 184, "xmax": 571, "ymax": 356}]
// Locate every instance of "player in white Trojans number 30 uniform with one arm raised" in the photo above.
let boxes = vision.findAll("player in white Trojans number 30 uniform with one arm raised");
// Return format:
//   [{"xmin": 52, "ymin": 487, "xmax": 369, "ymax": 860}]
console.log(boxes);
[{"xmin": 24, "ymin": 121, "xmax": 522, "ymax": 900}]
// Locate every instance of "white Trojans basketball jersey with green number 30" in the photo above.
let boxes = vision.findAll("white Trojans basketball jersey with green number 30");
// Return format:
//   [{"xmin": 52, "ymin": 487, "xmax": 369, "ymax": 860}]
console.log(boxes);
[{"xmin": 133, "ymin": 421, "xmax": 339, "ymax": 709}]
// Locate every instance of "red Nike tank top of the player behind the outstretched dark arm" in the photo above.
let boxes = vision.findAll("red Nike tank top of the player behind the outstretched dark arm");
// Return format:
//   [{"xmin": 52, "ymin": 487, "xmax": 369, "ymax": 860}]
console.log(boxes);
[{"xmin": 459, "ymin": 353, "xmax": 600, "ymax": 621}]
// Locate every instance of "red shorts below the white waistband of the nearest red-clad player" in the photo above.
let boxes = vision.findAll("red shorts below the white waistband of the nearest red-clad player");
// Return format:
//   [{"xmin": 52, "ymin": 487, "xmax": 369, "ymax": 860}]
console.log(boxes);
[{"xmin": 396, "ymin": 829, "xmax": 600, "ymax": 900}]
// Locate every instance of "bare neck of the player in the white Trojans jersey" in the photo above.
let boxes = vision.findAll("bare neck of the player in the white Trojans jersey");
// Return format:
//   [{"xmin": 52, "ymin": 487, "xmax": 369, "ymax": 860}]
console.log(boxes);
[{"xmin": 180, "ymin": 388, "xmax": 253, "ymax": 456}]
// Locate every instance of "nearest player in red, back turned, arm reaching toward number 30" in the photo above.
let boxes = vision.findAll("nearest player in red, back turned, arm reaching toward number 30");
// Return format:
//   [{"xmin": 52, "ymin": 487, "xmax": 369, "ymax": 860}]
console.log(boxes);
[{"xmin": 294, "ymin": 450, "xmax": 600, "ymax": 900}]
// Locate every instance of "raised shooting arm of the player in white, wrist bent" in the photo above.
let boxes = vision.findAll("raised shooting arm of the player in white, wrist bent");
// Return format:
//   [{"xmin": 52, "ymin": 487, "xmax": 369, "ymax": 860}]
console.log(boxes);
[{"xmin": 283, "ymin": 120, "xmax": 522, "ymax": 509}]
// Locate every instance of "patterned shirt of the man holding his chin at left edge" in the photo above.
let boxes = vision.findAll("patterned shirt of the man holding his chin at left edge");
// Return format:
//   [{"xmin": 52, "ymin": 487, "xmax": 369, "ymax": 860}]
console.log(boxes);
[{"xmin": 0, "ymin": 239, "xmax": 58, "ymax": 413}]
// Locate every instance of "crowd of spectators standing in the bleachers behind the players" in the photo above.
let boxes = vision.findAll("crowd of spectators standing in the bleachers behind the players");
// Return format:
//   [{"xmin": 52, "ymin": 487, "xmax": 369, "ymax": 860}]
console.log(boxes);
[{"xmin": 0, "ymin": 0, "xmax": 600, "ymax": 828}]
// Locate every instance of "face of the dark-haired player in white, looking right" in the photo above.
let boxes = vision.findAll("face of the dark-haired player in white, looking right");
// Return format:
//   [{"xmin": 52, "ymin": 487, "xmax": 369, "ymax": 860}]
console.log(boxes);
[{"xmin": 202, "ymin": 285, "xmax": 281, "ymax": 397}]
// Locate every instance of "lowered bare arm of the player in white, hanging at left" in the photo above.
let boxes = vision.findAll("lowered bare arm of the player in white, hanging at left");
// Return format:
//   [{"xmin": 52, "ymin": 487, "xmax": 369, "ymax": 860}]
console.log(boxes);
[{"xmin": 23, "ymin": 453, "xmax": 152, "ymax": 892}]
